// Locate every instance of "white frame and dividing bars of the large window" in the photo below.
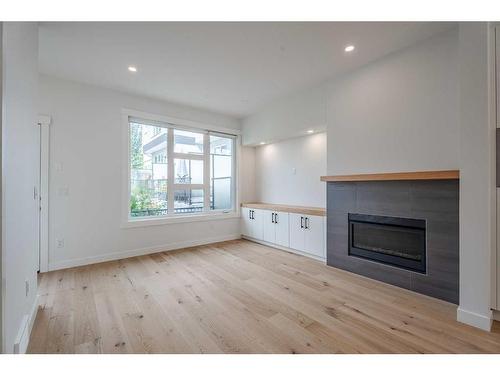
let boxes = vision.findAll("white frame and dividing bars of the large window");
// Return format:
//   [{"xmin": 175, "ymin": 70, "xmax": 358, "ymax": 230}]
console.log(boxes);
[{"xmin": 121, "ymin": 109, "xmax": 241, "ymax": 228}]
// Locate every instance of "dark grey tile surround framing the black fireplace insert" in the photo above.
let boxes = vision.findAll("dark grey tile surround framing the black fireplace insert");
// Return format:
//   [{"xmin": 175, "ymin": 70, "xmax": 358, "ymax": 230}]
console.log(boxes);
[{"xmin": 327, "ymin": 180, "xmax": 459, "ymax": 304}]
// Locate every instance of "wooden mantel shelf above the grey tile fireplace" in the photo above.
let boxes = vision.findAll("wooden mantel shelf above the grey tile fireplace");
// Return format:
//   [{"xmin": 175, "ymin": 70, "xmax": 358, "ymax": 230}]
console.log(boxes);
[{"xmin": 321, "ymin": 170, "xmax": 460, "ymax": 182}]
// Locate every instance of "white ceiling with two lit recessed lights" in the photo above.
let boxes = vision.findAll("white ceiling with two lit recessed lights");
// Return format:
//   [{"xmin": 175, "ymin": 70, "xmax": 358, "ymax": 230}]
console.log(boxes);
[{"xmin": 39, "ymin": 22, "xmax": 454, "ymax": 117}]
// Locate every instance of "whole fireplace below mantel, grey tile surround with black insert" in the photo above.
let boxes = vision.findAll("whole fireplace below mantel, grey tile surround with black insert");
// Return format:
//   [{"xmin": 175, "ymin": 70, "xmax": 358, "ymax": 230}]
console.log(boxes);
[{"xmin": 327, "ymin": 175, "xmax": 459, "ymax": 304}]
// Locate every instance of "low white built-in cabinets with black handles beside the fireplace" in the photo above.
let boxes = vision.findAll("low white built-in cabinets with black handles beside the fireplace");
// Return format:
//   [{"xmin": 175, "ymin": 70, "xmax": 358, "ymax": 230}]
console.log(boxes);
[{"xmin": 241, "ymin": 206, "xmax": 326, "ymax": 259}]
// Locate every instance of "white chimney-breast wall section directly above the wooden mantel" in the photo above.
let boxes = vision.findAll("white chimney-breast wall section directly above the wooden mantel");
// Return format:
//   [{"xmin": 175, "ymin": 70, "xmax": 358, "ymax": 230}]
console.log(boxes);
[{"xmin": 327, "ymin": 29, "xmax": 459, "ymax": 175}]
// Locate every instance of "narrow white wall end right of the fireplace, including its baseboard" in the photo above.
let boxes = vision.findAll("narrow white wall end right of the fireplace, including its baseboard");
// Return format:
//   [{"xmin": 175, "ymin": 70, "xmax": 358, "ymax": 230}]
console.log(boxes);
[{"xmin": 458, "ymin": 22, "xmax": 495, "ymax": 329}]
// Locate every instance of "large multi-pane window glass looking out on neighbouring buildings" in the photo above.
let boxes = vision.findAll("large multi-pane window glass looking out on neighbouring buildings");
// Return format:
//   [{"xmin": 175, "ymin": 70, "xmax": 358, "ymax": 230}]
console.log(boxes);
[{"xmin": 128, "ymin": 118, "xmax": 235, "ymax": 219}]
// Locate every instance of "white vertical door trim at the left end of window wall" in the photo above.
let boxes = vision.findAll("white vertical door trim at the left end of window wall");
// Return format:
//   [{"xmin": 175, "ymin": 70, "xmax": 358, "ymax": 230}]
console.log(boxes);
[{"xmin": 38, "ymin": 115, "xmax": 52, "ymax": 272}]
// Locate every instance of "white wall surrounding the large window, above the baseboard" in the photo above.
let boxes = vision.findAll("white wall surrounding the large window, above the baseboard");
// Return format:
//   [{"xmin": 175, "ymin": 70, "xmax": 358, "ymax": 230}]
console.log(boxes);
[{"xmin": 40, "ymin": 75, "xmax": 240, "ymax": 269}]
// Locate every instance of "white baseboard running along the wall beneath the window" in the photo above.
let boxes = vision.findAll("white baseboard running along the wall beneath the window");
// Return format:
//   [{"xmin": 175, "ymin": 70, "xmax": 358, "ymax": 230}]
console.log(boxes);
[{"xmin": 49, "ymin": 233, "xmax": 241, "ymax": 271}]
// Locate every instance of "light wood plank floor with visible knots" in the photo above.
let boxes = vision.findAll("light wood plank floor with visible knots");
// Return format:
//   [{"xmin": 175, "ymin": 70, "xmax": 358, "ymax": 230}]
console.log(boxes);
[{"xmin": 29, "ymin": 240, "xmax": 500, "ymax": 353}]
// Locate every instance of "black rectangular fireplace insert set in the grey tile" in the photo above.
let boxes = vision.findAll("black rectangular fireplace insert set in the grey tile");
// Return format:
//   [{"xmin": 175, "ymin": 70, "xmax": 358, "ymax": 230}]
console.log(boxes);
[{"xmin": 348, "ymin": 213, "xmax": 426, "ymax": 273}]
